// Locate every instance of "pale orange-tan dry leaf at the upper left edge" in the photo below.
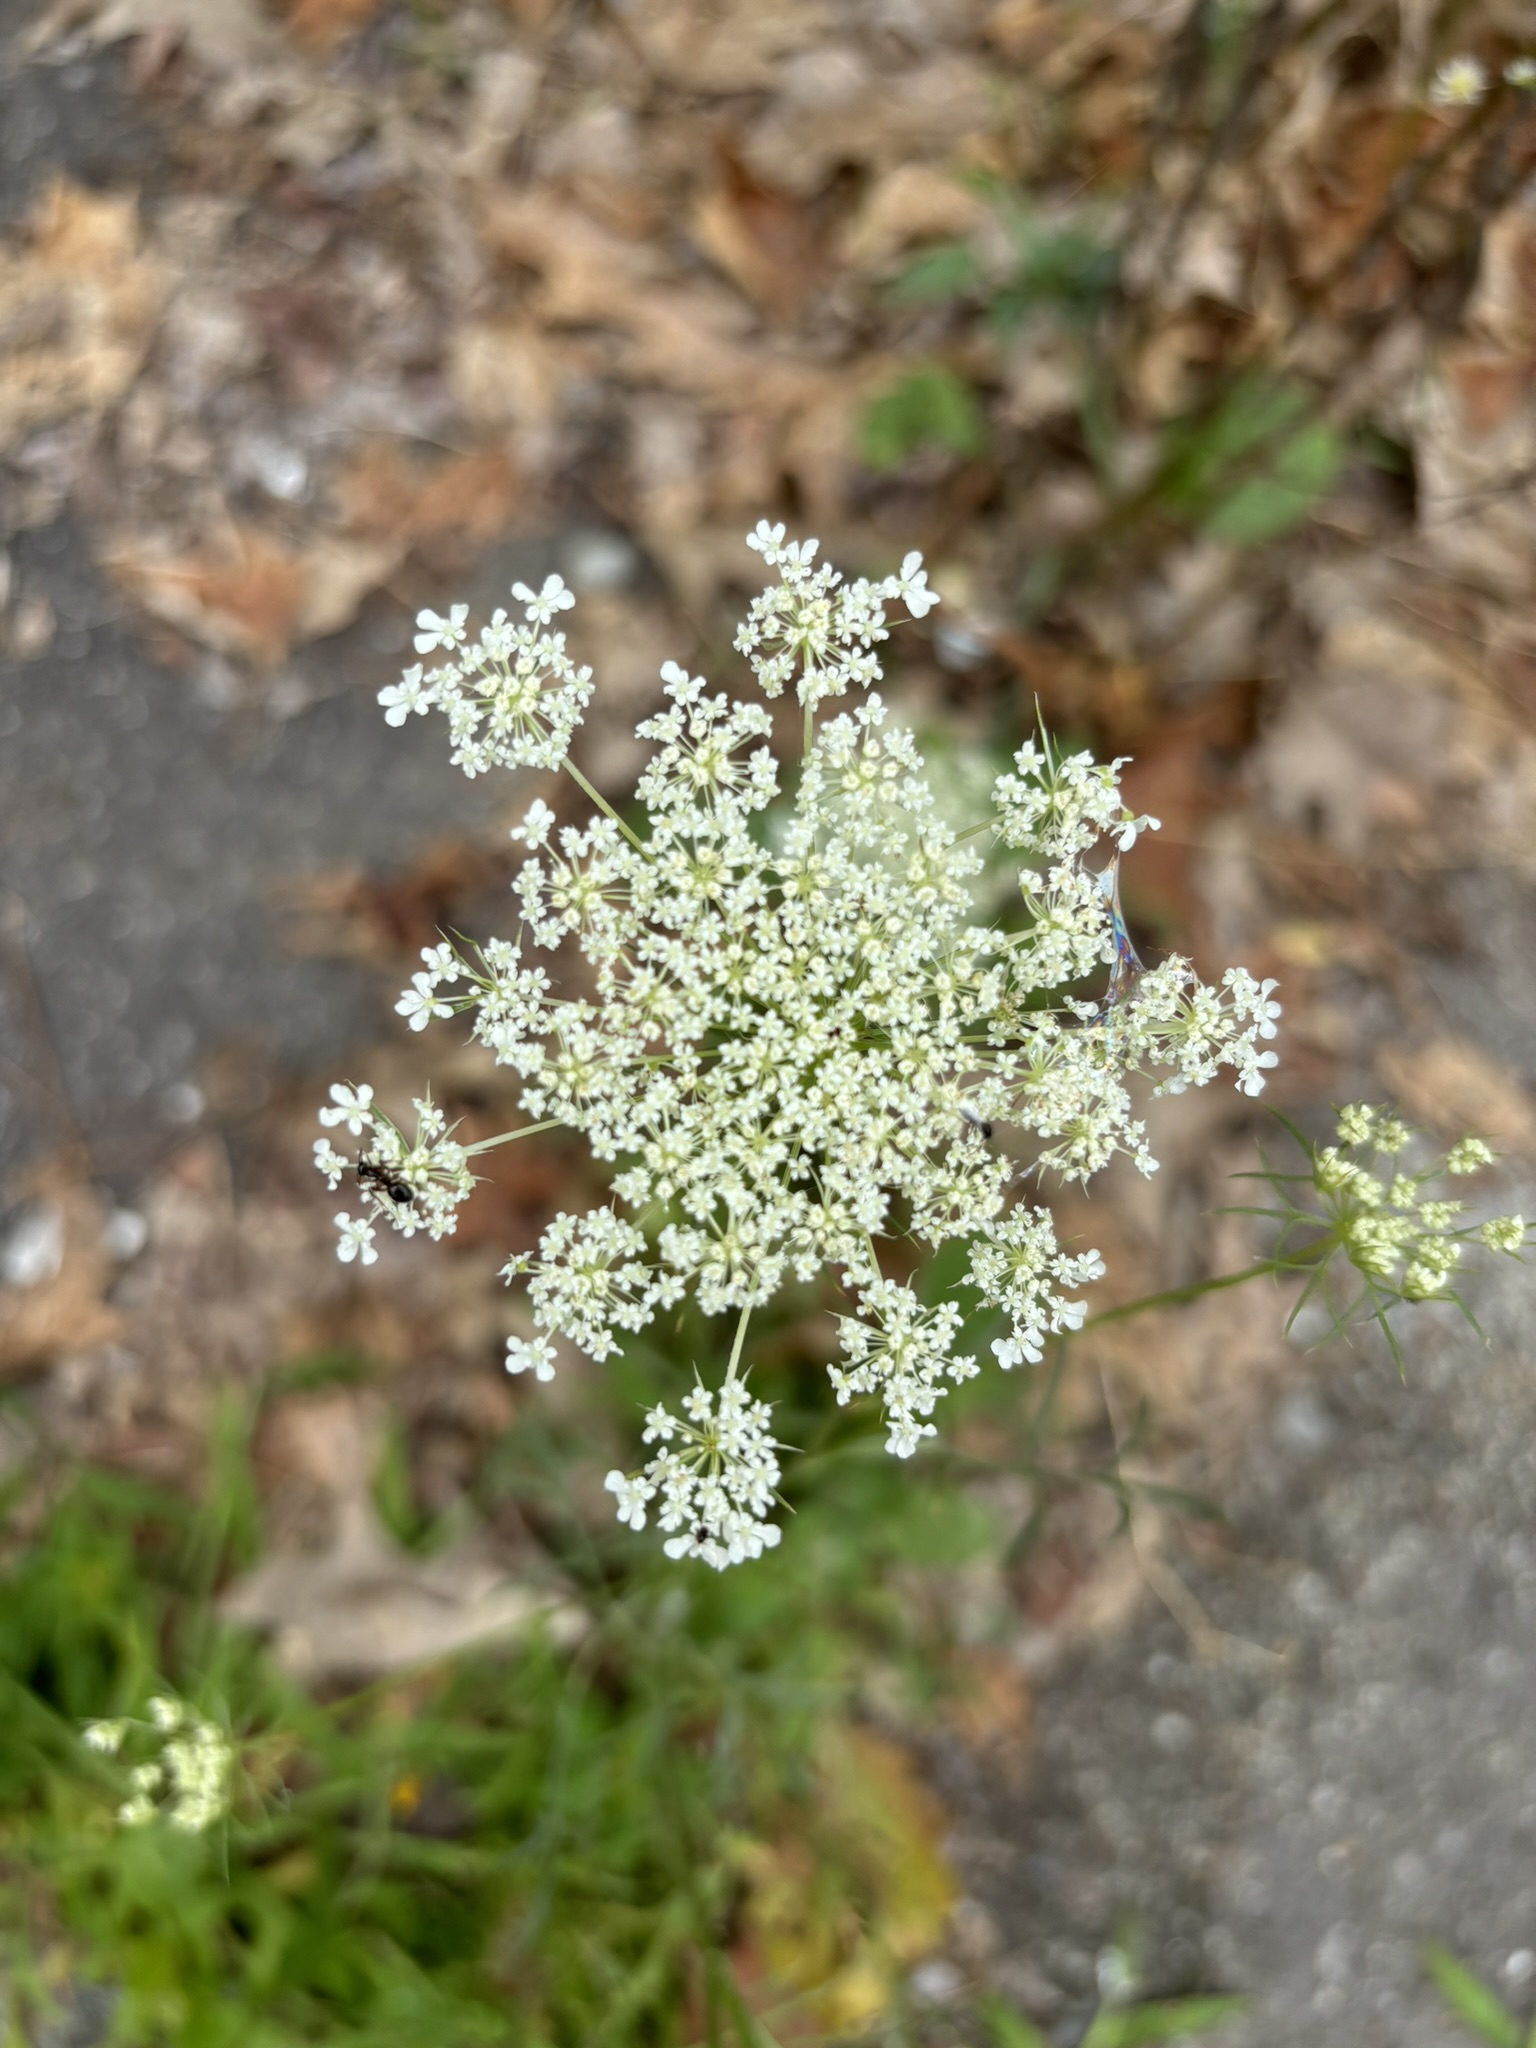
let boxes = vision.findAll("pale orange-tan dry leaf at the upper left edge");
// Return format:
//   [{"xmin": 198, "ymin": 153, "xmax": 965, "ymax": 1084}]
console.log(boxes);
[{"xmin": 0, "ymin": 178, "xmax": 172, "ymax": 449}]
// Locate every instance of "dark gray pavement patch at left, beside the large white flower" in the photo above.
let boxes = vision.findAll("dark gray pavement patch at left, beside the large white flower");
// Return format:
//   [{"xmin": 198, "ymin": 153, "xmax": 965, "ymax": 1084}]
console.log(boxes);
[{"xmin": 0, "ymin": 522, "xmax": 537, "ymax": 1176}]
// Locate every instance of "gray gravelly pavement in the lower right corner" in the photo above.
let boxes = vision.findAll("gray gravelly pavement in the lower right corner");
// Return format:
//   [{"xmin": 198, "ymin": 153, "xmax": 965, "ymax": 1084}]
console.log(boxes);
[{"xmin": 948, "ymin": 1138, "xmax": 1536, "ymax": 2048}]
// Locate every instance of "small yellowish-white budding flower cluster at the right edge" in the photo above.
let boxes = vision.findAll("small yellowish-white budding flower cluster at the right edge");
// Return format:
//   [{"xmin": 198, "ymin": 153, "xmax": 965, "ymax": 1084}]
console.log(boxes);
[{"xmin": 1313, "ymin": 1102, "xmax": 1526, "ymax": 1300}]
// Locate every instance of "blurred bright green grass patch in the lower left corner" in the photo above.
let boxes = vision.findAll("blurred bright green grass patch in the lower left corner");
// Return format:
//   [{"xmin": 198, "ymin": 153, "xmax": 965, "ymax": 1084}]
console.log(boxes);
[{"xmin": 0, "ymin": 1449, "xmax": 846, "ymax": 2048}]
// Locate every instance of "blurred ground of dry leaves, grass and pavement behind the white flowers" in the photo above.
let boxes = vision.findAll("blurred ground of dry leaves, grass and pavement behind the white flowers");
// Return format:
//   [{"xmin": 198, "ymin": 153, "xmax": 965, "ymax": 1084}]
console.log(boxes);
[{"xmin": 0, "ymin": 0, "xmax": 1536, "ymax": 2048}]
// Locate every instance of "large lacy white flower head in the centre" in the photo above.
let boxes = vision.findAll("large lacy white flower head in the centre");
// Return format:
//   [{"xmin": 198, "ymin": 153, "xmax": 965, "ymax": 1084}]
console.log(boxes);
[{"xmin": 315, "ymin": 522, "xmax": 1278, "ymax": 1567}]
